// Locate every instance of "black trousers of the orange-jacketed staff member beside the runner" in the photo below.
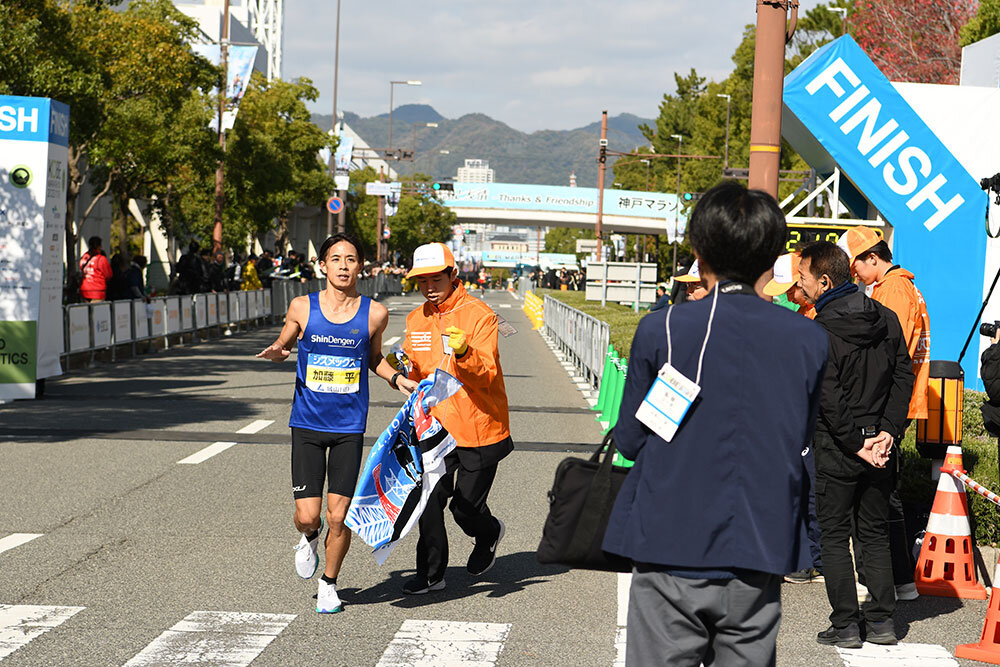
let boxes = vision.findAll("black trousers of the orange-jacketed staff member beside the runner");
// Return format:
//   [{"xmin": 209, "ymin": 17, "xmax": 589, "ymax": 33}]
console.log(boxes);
[{"xmin": 417, "ymin": 438, "xmax": 512, "ymax": 582}]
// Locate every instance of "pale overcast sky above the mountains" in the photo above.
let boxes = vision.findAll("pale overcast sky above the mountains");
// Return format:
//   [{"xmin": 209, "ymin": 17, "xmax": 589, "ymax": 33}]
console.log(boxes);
[{"xmin": 283, "ymin": 0, "xmax": 818, "ymax": 132}]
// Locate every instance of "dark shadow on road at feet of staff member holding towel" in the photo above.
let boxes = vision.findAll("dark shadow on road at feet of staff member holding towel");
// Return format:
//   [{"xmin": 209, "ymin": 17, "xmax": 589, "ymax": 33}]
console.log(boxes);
[{"xmin": 338, "ymin": 551, "xmax": 568, "ymax": 609}]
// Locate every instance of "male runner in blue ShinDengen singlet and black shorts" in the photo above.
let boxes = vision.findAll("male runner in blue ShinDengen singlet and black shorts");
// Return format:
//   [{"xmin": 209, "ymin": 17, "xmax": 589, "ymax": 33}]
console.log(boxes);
[{"xmin": 257, "ymin": 234, "xmax": 417, "ymax": 614}]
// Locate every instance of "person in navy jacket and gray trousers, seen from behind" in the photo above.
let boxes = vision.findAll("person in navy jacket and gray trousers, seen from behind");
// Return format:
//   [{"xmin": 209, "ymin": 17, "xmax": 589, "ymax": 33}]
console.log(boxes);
[{"xmin": 604, "ymin": 183, "xmax": 827, "ymax": 666}]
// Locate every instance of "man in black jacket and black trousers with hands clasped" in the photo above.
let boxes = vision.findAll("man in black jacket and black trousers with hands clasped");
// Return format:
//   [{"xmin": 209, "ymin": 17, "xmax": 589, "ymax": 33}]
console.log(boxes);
[{"xmin": 799, "ymin": 241, "xmax": 913, "ymax": 648}]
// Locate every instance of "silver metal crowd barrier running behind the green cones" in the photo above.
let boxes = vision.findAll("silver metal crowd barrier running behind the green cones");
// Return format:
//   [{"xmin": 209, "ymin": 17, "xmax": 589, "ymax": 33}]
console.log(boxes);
[{"xmin": 543, "ymin": 296, "xmax": 611, "ymax": 388}]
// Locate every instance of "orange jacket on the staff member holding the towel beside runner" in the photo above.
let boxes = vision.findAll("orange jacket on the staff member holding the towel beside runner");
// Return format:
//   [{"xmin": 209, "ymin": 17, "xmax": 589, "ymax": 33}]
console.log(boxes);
[{"xmin": 403, "ymin": 285, "xmax": 510, "ymax": 447}]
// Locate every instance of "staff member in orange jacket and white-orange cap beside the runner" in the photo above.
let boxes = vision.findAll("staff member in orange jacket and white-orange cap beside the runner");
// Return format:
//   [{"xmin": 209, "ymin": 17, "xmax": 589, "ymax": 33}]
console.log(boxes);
[{"xmin": 403, "ymin": 243, "xmax": 514, "ymax": 595}]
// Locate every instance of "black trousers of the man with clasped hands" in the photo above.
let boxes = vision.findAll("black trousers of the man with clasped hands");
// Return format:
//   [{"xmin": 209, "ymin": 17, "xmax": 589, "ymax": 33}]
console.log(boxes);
[{"xmin": 816, "ymin": 454, "xmax": 896, "ymax": 628}]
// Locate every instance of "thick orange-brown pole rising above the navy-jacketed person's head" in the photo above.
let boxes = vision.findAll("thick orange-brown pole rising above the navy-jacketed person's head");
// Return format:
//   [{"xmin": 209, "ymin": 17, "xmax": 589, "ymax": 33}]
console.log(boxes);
[{"xmin": 749, "ymin": 0, "xmax": 799, "ymax": 199}]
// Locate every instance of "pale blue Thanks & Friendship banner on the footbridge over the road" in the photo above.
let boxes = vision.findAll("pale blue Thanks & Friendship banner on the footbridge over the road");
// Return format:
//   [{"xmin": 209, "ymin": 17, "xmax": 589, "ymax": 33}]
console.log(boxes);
[{"xmin": 438, "ymin": 183, "xmax": 687, "ymax": 222}]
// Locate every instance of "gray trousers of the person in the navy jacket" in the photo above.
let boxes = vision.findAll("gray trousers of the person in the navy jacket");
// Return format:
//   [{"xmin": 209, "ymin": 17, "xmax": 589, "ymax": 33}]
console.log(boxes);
[{"xmin": 625, "ymin": 565, "xmax": 781, "ymax": 667}]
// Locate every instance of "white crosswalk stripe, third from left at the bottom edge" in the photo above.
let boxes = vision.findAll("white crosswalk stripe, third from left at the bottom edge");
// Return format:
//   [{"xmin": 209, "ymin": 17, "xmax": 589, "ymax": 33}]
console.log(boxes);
[{"xmin": 375, "ymin": 620, "xmax": 510, "ymax": 667}]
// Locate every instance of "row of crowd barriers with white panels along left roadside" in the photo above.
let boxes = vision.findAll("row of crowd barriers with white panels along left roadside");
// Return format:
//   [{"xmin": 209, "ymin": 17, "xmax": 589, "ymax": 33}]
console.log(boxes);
[{"xmin": 61, "ymin": 289, "xmax": 272, "ymax": 360}]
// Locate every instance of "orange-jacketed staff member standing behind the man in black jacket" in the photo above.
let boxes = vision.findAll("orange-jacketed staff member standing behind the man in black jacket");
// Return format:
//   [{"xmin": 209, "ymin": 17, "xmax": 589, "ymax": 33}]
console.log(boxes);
[{"xmin": 837, "ymin": 225, "xmax": 931, "ymax": 600}]
